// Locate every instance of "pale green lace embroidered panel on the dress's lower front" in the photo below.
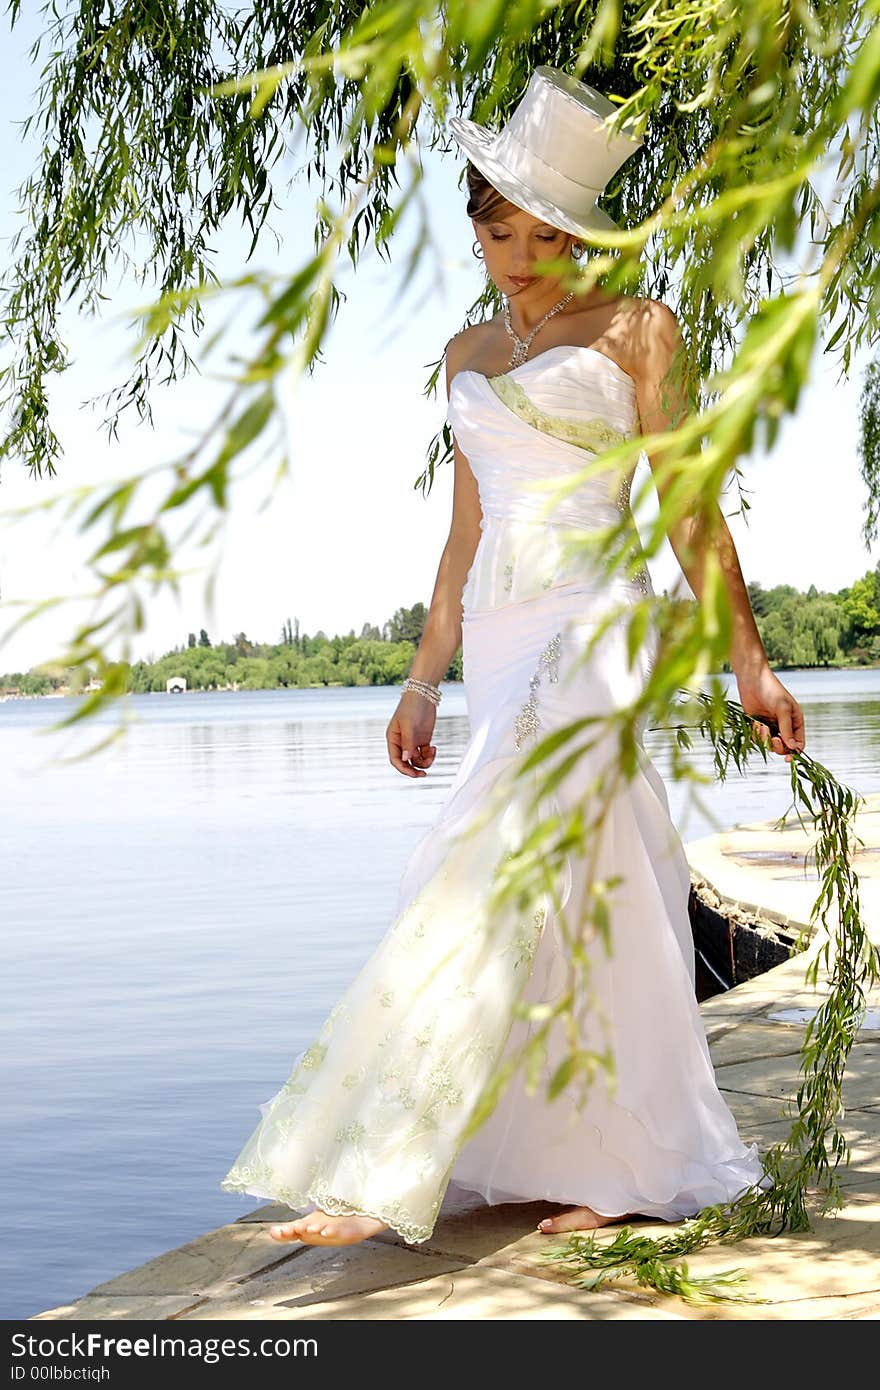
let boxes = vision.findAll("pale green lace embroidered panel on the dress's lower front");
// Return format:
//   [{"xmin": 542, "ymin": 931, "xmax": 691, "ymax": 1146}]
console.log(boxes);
[{"xmin": 221, "ymin": 839, "xmax": 545, "ymax": 1244}]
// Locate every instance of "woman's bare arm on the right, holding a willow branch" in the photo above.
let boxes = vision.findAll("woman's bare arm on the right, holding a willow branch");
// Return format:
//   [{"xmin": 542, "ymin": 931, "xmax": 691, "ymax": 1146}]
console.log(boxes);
[{"xmin": 633, "ymin": 300, "xmax": 805, "ymax": 762}]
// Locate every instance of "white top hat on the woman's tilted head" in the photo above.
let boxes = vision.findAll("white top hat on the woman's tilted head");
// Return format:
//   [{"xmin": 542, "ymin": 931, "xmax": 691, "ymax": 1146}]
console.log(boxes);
[{"xmin": 449, "ymin": 65, "xmax": 645, "ymax": 235}]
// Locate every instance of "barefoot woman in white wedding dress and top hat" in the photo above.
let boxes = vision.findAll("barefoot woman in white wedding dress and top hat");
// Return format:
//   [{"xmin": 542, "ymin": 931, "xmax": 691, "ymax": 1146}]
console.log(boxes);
[{"xmin": 221, "ymin": 67, "xmax": 804, "ymax": 1245}]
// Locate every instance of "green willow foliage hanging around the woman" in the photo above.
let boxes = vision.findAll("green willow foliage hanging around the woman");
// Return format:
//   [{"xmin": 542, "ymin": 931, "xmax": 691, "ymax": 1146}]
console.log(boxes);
[{"xmin": 0, "ymin": 0, "xmax": 880, "ymax": 1297}]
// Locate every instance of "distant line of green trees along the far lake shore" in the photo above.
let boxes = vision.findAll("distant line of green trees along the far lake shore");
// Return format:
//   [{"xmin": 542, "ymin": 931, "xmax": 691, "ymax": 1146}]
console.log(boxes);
[{"xmin": 0, "ymin": 564, "xmax": 880, "ymax": 695}]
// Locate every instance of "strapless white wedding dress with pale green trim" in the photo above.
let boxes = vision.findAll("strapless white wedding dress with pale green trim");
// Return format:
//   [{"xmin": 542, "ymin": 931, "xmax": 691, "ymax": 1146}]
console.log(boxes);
[{"xmin": 221, "ymin": 345, "xmax": 762, "ymax": 1243}]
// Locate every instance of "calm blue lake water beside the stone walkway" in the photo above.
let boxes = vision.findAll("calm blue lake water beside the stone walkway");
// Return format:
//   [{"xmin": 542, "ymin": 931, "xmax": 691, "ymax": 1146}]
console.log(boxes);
[{"xmin": 0, "ymin": 670, "xmax": 880, "ymax": 1318}]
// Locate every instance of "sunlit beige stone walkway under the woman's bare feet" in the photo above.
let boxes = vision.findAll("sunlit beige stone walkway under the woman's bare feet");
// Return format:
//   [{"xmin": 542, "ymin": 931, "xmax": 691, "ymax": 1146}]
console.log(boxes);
[{"xmin": 33, "ymin": 796, "xmax": 880, "ymax": 1321}]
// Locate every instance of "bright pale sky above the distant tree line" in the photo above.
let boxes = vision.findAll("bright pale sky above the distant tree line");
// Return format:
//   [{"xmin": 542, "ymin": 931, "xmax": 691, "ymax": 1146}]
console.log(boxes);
[{"xmin": 0, "ymin": 15, "xmax": 880, "ymax": 673}]
